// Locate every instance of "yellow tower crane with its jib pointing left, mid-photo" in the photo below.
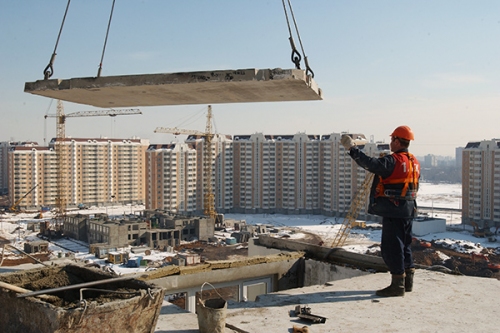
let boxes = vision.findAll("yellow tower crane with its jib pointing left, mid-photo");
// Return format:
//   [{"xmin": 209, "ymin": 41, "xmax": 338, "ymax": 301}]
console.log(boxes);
[{"xmin": 154, "ymin": 105, "xmax": 217, "ymax": 223}]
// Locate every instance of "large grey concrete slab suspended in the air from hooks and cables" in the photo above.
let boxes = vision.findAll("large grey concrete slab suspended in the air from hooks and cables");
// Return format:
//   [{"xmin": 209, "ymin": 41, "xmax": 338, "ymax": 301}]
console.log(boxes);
[{"xmin": 24, "ymin": 68, "xmax": 322, "ymax": 108}]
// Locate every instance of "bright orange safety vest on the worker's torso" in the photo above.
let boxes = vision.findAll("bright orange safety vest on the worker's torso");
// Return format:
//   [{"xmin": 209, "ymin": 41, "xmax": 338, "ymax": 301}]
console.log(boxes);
[{"xmin": 375, "ymin": 152, "xmax": 420, "ymax": 200}]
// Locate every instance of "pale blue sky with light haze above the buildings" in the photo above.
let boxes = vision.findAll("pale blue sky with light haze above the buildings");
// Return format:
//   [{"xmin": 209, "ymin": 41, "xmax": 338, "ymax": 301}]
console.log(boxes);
[{"xmin": 0, "ymin": 0, "xmax": 500, "ymax": 156}]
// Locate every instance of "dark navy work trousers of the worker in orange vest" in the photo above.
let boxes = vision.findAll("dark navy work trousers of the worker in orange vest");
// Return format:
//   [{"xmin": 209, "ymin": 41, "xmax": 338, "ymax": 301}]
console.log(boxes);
[{"xmin": 380, "ymin": 217, "xmax": 415, "ymax": 275}]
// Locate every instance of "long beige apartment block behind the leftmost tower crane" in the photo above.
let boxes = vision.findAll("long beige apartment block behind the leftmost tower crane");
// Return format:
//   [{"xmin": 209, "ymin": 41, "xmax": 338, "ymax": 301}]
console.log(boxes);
[{"xmin": 9, "ymin": 138, "xmax": 149, "ymax": 207}]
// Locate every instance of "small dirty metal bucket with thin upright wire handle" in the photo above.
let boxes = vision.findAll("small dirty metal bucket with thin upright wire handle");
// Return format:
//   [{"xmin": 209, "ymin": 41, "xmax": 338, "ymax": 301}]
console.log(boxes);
[{"xmin": 196, "ymin": 282, "xmax": 227, "ymax": 333}]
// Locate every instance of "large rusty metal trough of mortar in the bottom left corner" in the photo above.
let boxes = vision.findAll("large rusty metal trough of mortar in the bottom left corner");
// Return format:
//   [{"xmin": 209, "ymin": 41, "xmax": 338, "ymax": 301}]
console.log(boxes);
[{"xmin": 0, "ymin": 265, "xmax": 165, "ymax": 333}]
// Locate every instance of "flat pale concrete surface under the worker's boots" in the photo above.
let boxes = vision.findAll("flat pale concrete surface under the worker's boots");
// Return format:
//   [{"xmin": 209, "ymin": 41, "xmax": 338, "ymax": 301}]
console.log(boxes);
[{"xmin": 155, "ymin": 269, "xmax": 500, "ymax": 333}]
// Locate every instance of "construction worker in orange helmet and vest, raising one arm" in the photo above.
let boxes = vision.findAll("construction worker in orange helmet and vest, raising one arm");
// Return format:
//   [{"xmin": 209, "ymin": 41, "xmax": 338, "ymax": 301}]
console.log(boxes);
[{"xmin": 340, "ymin": 126, "xmax": 420, "ymax": 297}]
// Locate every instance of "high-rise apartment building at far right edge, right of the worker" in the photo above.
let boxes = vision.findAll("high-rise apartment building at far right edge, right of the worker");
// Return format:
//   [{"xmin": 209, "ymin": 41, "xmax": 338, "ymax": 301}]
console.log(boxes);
[{"xmin": 462, "ymin": 139, "xmax": 500, "ymax": 227}]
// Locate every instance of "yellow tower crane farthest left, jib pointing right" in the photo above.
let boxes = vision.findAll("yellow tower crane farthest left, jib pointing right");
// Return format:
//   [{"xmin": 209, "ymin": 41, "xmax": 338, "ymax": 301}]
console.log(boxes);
[{"xmin": 45, "ymin": 100, "xmax": 142, "ymax": 222}]
